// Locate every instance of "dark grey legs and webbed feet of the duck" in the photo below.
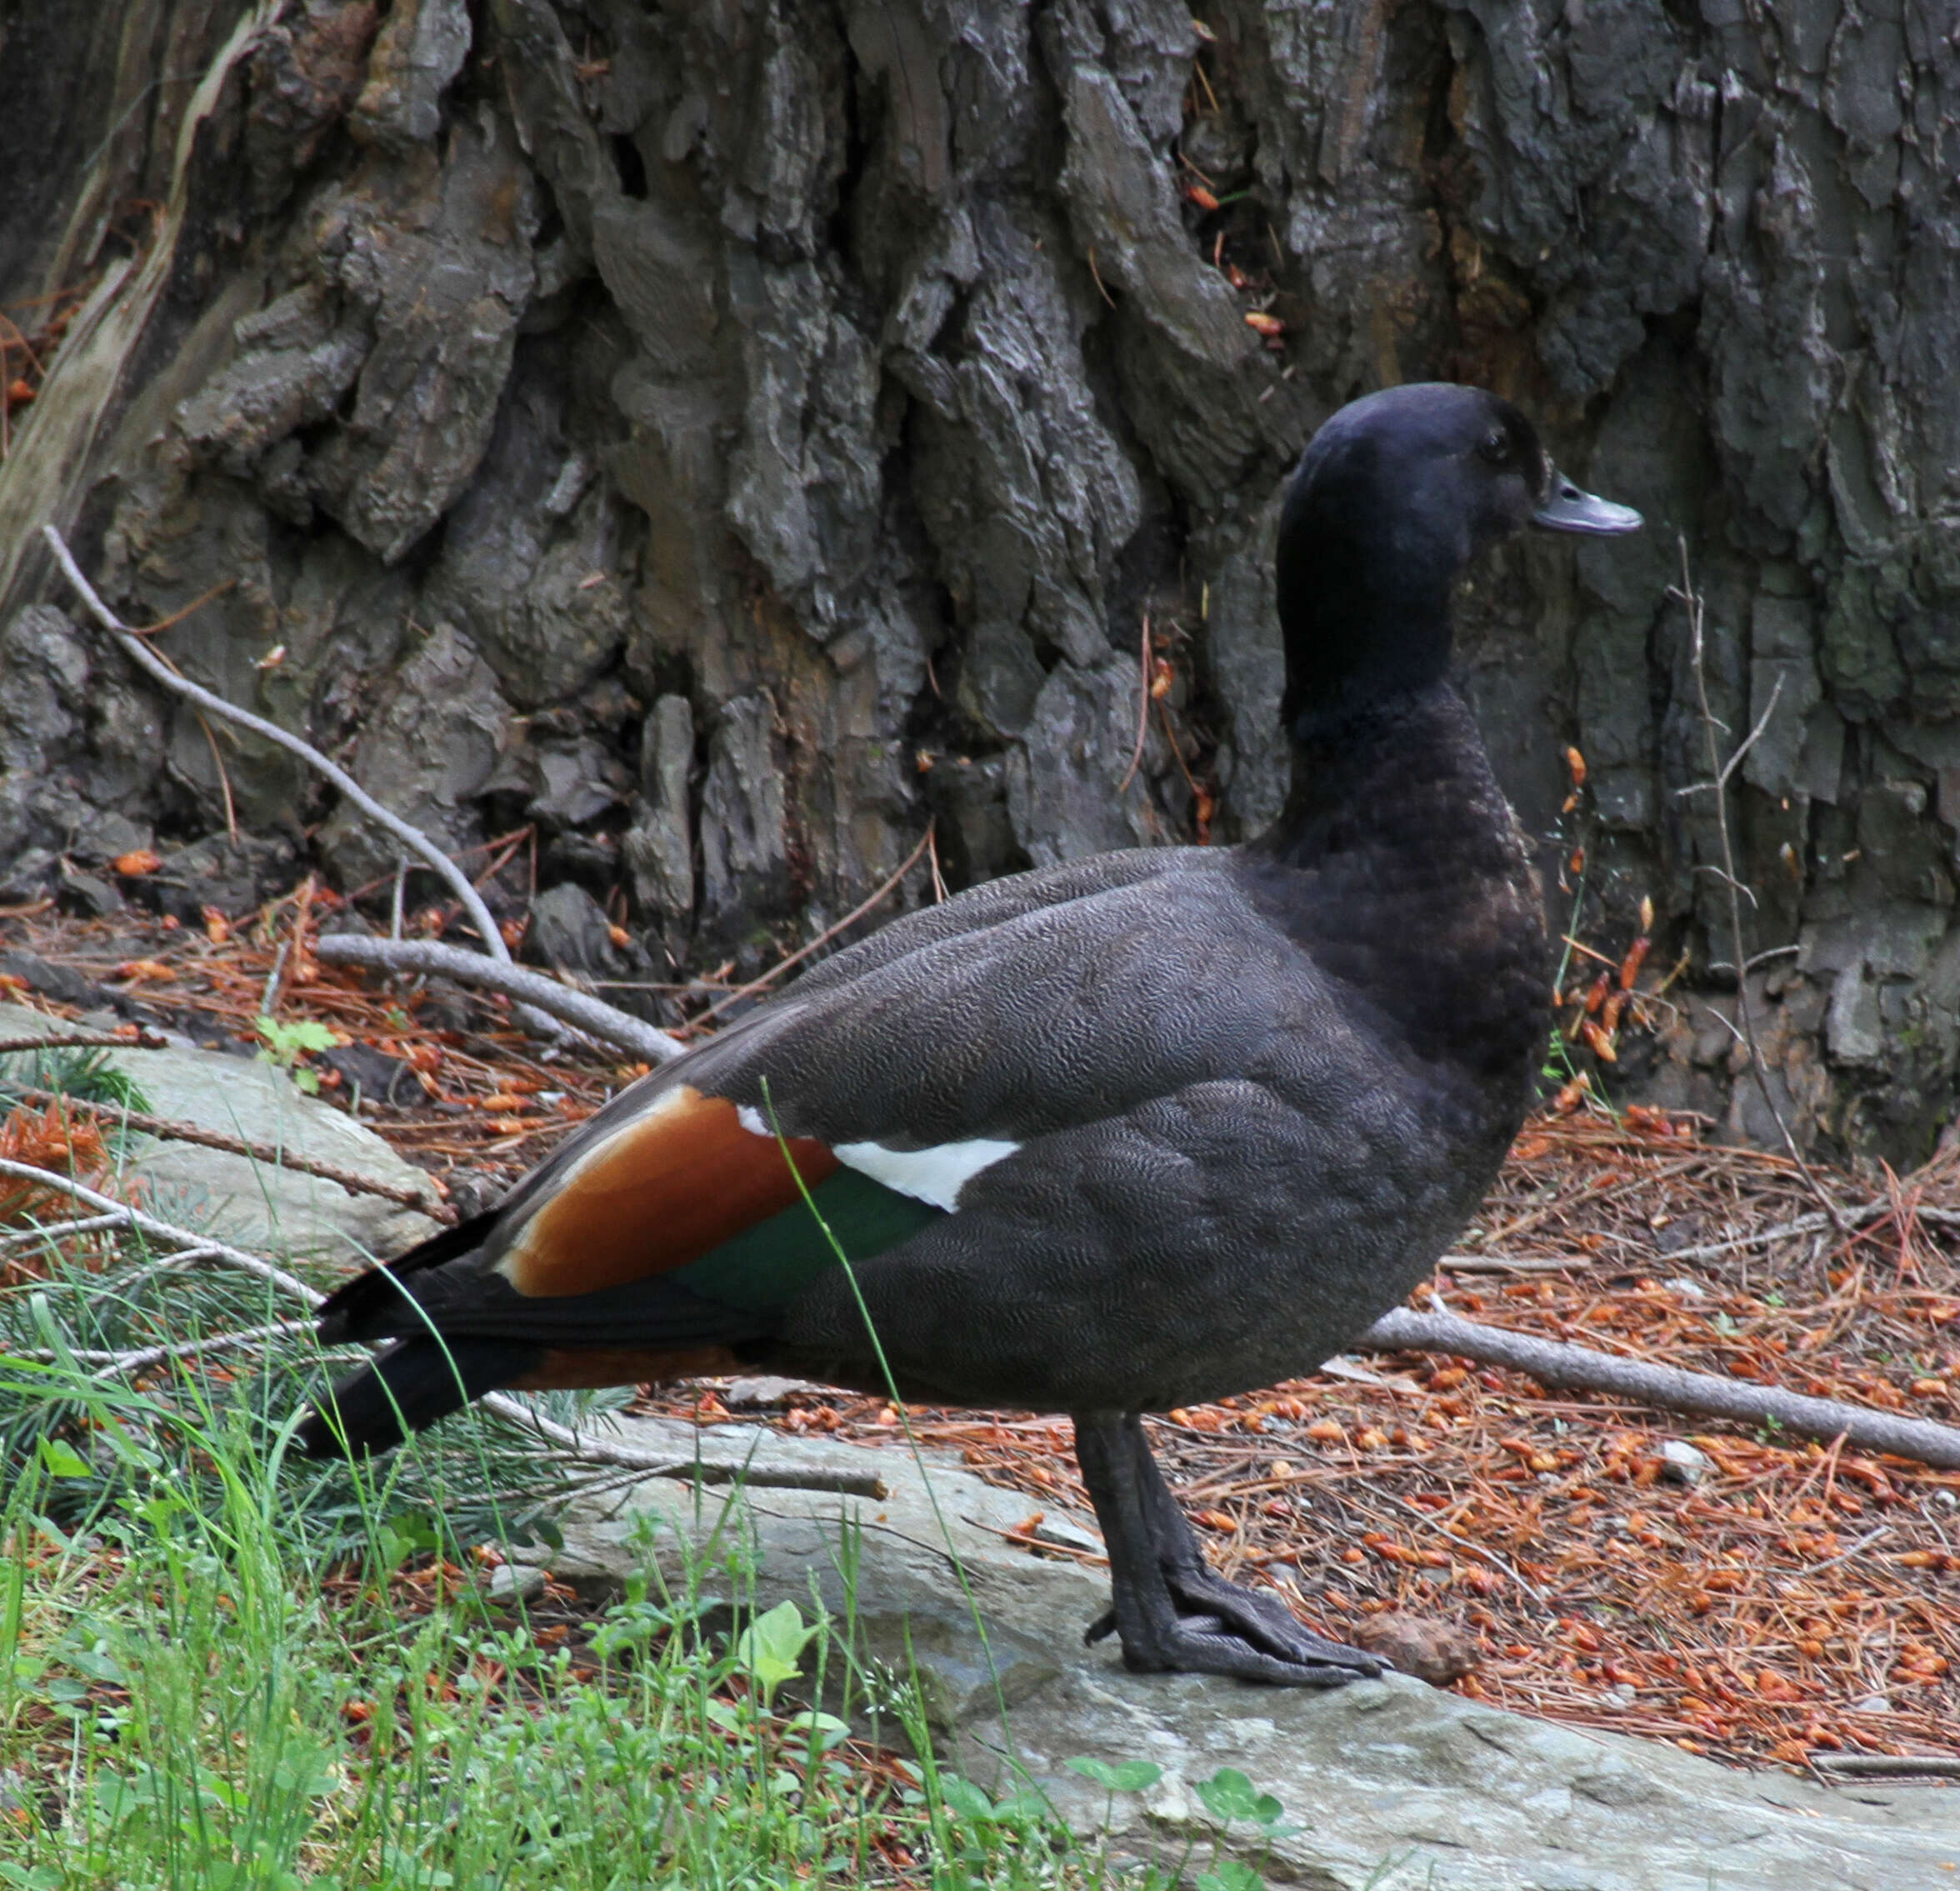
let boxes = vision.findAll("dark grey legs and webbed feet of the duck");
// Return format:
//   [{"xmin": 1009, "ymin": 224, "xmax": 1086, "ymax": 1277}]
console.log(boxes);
[{"xmin": 1074, "ymin": 1411, "xmax": 1388, "ymax": 1687}]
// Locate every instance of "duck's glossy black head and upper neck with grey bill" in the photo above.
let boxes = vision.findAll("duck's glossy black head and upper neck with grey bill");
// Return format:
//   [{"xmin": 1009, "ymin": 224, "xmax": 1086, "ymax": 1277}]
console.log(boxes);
[{"xmin": 1276, "ymin": 380, "xmax": 1641, "ymax": 738}]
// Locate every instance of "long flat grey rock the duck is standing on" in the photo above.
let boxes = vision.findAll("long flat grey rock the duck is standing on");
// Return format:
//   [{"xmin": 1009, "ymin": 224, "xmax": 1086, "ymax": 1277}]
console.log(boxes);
[{"xmin": 549, "ymin": 1418, "xmax": 1960, "ymax": 1891}]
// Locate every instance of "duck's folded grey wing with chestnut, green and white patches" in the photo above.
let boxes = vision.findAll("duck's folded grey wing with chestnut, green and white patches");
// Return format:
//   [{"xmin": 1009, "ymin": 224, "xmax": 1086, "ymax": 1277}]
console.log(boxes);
[{"xmin": 298, "ymin": 850, "xmax": 1356, "ymax": 1443}]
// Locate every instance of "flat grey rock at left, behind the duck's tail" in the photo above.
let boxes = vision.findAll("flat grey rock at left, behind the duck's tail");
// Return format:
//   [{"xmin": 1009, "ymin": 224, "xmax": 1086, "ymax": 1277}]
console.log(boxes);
[{"xmin": 0, "ymin": 1005, "xmax": 437, "ymax": 1264}]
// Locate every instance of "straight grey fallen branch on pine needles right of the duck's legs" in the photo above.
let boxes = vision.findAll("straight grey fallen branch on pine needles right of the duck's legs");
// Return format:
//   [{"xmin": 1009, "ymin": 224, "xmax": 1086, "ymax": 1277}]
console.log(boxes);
[{"xmin": 1357, "ymin": 1307, "xmax": 1960, "ymax": 1472}]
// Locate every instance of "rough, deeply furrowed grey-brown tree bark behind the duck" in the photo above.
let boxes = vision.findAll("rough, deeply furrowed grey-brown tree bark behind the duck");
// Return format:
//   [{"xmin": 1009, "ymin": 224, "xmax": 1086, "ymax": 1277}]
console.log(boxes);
[{"xmin": 0, "ymin": 0, "xmax": 1960, "ymax": 1160}]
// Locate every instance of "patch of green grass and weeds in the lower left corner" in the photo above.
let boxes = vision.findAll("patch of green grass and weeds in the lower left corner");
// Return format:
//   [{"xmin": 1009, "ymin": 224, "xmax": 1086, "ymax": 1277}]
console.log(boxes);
[{"xmin": 0, "ymin": 1228, "xmax": 1207, "ymax": 1891}]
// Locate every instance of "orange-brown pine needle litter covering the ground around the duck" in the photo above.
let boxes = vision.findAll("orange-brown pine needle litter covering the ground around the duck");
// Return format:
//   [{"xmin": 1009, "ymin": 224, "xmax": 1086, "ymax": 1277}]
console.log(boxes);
[{"xmin": 0, "ymin": 911, "xmax": 1960, "ymax": 1766}]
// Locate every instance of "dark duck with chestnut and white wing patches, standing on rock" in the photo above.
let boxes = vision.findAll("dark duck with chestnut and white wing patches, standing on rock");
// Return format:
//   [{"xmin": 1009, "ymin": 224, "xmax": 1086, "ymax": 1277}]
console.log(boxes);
[{"xmin": 300, "ymin": 383, "xmax": 1641, "ymax": 1685}]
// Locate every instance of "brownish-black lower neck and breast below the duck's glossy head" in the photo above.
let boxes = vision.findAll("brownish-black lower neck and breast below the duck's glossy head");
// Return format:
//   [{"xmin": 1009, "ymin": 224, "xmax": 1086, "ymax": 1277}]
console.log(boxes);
[{"xmin": 1245, "ymin": 682, "xmax": 1550, "ymax": 1081}]
